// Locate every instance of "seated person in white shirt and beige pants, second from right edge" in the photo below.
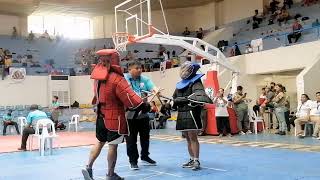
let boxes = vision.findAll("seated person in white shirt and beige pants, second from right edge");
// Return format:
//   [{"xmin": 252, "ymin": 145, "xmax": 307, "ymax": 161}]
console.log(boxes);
[{"xmin": 294, "ymin": 94, "xmax": 312, "ymax": 138}]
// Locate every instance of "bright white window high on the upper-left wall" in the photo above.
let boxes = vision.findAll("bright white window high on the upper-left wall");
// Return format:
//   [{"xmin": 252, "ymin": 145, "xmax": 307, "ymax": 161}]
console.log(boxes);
[{"xmin": 28, "ymin": 15, "xmax": 92, "ymax": 39}]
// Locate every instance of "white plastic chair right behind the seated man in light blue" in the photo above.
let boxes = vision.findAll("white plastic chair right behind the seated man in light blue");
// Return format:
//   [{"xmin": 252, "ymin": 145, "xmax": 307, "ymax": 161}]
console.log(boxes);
[{"xmin": 29, "ymin": 119, "xmax": 58, "ymax": 156}]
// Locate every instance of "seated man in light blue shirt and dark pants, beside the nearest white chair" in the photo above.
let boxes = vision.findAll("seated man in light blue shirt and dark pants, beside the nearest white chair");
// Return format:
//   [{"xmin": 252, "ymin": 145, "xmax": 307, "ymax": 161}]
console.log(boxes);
[{"xmin": 18, "ymin": 104, "xmax": 48, "ymax": 151}]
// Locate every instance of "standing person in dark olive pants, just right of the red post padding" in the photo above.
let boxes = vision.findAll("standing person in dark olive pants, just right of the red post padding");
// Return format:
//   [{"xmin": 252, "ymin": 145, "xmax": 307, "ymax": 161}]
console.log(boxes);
[{"xmin": 233, "ymin": 86, "xmax": 252, "ymax": 135}]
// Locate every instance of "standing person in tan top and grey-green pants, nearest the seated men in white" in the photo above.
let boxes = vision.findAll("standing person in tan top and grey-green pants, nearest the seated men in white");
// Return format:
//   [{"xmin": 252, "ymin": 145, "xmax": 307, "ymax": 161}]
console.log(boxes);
[{"xmin": 272, "ymin": 84, "xmax": 287, "ymax": 135}]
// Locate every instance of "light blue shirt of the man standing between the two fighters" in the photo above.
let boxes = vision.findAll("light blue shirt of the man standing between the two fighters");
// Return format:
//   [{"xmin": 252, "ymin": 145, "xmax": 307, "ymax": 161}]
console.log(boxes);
[{"xmin": 124, "ymin": 74, "xmax": 155, "ymax": 97}]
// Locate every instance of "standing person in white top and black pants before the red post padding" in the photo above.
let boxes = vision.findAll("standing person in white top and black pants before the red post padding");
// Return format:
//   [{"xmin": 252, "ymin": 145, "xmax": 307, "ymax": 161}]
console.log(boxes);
[{"xmin": 213, "ymin": 88, "xmax": 232, "ymax": 137}]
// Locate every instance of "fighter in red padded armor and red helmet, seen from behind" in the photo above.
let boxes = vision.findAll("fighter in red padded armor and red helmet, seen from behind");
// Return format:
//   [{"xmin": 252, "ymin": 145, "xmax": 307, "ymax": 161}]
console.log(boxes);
[{"xmin": 82, "ymin": 49, "xmax": 143, "ymax": 180}]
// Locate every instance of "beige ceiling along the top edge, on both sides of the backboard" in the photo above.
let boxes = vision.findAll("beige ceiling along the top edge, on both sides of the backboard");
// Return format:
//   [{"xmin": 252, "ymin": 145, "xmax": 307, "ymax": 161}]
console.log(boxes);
[{"xmin": 0, "ymin": 0, "xmax": 222, "ymax": 16}]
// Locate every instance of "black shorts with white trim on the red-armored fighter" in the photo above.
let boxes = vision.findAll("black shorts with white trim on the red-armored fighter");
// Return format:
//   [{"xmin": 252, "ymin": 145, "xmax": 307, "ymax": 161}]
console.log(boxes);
[{"xmin": 96, "ymin": 115, "xmax": 124, "ymax": 144}]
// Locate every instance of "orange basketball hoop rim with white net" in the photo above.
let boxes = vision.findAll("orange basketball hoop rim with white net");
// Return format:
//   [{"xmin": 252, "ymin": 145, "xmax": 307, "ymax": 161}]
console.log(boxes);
[{"xmin": 112, "ymin": 32, "xmax": 135, "ymax": 52}]
